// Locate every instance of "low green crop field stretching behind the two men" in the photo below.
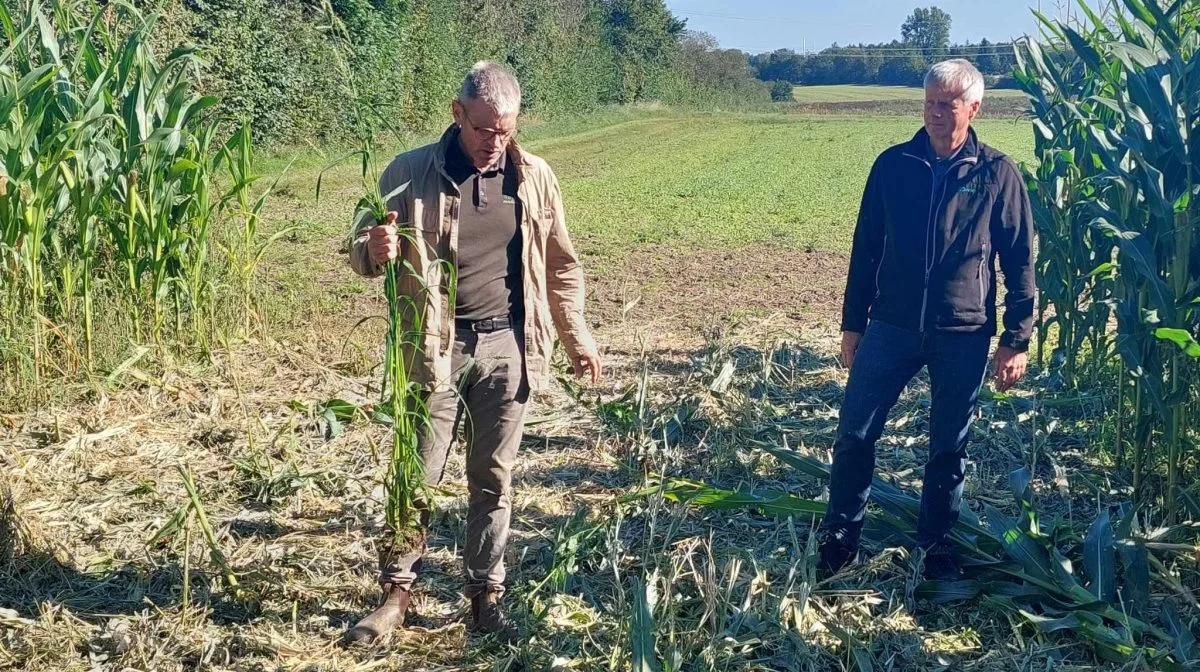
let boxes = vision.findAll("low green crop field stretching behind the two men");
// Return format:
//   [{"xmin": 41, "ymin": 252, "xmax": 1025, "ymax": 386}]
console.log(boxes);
[{"xmin": 533, "ymin": 115, "xmax": 1032, "ymax": 257}]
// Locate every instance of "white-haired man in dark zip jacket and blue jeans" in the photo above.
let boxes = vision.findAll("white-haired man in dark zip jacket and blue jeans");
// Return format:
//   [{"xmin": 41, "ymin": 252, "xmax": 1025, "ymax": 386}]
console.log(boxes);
[{"xmin": 820, "ymin": 59, "xmax": 1034, "ymax": 580}]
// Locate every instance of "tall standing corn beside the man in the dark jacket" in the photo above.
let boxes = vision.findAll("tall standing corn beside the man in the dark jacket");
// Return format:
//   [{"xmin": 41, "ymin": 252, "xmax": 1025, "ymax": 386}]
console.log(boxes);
[{"xmin": 1018, "ymin": 0, "xmax": 1200, "ymax": 520}]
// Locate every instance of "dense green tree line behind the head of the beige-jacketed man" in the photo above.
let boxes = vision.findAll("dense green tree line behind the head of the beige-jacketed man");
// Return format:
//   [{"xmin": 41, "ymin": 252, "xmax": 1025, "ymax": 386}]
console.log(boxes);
[{"xmin": 129, "ymin": 0, "xmax": 769, "ymax": 143}]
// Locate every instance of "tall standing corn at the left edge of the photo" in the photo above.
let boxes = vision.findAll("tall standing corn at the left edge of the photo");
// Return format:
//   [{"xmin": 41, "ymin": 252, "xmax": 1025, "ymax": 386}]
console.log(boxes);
[{"xmin": 0, "ymin": 0, "xmax": 276, "ymax": 384}]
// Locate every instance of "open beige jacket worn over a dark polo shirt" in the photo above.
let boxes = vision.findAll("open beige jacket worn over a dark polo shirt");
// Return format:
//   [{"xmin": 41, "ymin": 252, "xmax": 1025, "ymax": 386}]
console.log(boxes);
[{"xmin": 350, "ymin": 128, "xmax": 596, "ymax": 390}]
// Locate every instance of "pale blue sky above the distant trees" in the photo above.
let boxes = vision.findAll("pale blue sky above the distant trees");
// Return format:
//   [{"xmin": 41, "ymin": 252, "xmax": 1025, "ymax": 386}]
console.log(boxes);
[{"xmin": 666, "ymin": 0, "xmax": 1056, "ymax": 53}]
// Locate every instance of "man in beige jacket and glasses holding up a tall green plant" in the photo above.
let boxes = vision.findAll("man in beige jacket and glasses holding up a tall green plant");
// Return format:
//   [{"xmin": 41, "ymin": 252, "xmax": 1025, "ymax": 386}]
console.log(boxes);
[{"xmin": 344, "ymin": 61, "xmax": 600, "ymax": 643}]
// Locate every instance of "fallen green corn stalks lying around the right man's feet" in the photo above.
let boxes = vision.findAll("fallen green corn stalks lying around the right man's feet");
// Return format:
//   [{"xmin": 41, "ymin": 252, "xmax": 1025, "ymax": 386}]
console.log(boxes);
[{"xmin": 648, "ymin": 446, "xmax": 1200, "ymax": 671}]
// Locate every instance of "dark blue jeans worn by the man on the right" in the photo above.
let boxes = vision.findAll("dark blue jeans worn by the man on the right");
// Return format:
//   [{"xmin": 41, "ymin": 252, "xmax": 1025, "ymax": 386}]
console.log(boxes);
[{"xmin": 824, "ymin": 320, "xmax": 991, "ymax": 547}]
